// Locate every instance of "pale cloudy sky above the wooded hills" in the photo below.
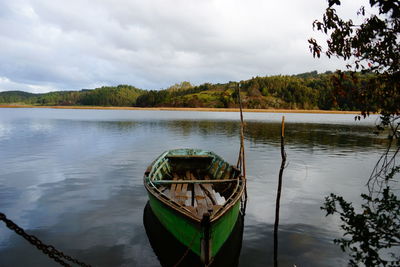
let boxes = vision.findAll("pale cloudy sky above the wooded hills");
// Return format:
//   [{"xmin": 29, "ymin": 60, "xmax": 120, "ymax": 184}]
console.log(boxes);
[{"xmin": 0, "ymin": 0, "xmax": 368, "ymax": 93}]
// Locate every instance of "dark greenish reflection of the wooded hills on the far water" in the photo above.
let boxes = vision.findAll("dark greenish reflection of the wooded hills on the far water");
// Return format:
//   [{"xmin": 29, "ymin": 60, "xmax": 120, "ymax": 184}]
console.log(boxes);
[{"xmin": 91, "ymin": 120, "xmax": 386, "ymax": 154}]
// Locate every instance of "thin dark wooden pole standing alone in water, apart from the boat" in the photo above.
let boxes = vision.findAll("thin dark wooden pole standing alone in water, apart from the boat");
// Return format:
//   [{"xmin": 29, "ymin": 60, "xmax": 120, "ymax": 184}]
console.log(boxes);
[{"xmin": 274, "ymin": 116, "xmax": 286, "ymax": 267}]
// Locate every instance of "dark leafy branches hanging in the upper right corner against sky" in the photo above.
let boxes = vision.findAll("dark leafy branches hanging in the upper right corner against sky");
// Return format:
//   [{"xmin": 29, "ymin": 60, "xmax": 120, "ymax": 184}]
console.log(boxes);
[{"xmin": 308, "ymin": 0, "xmax": 400, "ymax": 123}]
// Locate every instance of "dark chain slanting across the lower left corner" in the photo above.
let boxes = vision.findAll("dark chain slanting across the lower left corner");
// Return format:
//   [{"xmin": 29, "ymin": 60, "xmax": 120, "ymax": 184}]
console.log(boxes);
[{"xmin": 0, "ymin": 212, "xmax": 90, "ymax": 267}]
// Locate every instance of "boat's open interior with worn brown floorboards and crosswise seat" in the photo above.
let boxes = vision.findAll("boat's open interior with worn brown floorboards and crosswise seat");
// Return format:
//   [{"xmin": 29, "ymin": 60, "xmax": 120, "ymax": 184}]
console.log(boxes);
[{"xmin": 148, "ymin": 155, "xmax": 242, "ymax": 219}]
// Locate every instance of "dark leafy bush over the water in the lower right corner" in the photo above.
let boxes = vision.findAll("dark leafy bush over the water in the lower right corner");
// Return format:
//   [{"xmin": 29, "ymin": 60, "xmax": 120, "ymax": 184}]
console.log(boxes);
[{"xmin": 322, "ymin": 184, "xmax": 400, "ymax": 266}]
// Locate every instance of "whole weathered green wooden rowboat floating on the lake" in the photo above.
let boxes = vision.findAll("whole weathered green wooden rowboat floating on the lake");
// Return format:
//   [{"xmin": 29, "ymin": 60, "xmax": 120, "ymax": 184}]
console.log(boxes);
[{"xmin": 144, "ymin": 149, "xmax": 245, "ymax": 264}]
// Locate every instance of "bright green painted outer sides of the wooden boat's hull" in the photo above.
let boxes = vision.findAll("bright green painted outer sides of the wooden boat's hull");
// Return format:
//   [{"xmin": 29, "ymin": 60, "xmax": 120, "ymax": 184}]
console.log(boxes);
[{"xmin": 148, "ymin": 193, "xmax": 240, "ymax": 258}]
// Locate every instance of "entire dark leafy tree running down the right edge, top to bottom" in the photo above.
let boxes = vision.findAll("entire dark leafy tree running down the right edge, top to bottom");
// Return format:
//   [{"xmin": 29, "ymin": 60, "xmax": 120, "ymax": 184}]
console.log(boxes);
[{"xmin": 308, "ymin": 0, "xmax": 400, "ymax": 266}]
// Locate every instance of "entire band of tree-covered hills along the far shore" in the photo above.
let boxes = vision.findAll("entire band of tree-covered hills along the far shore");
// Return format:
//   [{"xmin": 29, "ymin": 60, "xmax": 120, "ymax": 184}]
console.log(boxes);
[{"xmin": 0, "ymin": 71, "xmax": 380, "ymax": 111}]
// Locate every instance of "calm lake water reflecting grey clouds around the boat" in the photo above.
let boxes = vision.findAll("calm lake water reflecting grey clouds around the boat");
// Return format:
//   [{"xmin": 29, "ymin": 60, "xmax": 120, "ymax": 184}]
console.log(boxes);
[{"xmin": 0, "ymin": 109, "xmax": 385, "ymax": 266}]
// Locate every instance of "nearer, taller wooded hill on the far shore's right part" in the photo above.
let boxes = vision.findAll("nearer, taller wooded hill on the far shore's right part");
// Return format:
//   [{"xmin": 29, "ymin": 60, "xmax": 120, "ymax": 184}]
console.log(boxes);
[{"xmin": 130, "ymin": 71, "xmax": 373, "ymax": 110}]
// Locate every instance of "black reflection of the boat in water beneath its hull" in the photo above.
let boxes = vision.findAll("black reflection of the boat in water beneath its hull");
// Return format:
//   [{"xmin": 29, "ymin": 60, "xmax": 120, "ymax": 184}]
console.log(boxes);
[{"xmin": 143, "ymin": 202, "xmax": 244, "ymax": 267}]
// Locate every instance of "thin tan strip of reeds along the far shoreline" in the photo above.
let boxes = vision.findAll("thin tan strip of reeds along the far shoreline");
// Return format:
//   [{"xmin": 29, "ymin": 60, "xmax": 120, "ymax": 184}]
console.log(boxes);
[{"xmin": 0, "ymin": 105, "xmax": 360, "ymax": 114}]
